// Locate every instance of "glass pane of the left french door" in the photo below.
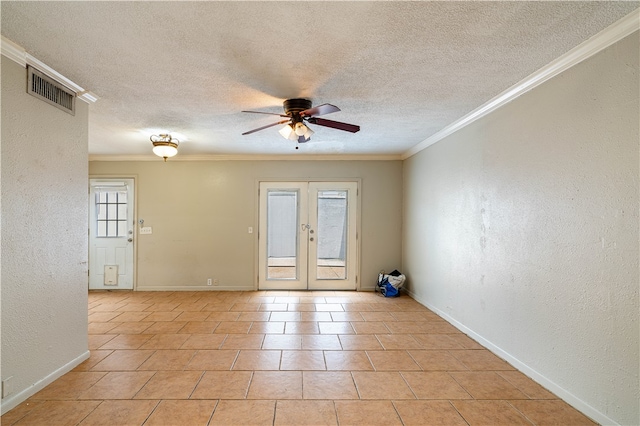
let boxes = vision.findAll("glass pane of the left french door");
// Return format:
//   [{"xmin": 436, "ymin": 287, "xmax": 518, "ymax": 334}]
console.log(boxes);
[{"xmin": 267, "ymin": 190, "xmax": 298, "ymax": 280}]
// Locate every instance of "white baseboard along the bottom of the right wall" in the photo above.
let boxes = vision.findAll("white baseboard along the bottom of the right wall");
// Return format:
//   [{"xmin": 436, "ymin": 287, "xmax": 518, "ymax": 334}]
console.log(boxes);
[{"xmin": 407, "ymin": 291, "xmax": 619, "ymax": 425}]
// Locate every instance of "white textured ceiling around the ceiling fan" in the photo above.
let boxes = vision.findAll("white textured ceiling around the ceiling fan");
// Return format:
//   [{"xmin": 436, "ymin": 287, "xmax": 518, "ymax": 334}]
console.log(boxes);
[{"xmin": 1, "ymin": 1, "xmax": 639, "ymax": 155}]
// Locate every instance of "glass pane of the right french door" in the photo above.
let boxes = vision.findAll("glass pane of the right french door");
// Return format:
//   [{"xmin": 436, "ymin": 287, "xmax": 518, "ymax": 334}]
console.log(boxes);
[{"xmin": 316, "ymin": 190, "xmax": 348, "ymax": 280}]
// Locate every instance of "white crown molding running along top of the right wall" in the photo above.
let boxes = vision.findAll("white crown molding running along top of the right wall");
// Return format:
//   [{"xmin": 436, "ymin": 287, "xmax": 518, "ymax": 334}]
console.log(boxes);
[{"xmin": 401, "ymin": 8, "xmax": 640, "ymax": 160}]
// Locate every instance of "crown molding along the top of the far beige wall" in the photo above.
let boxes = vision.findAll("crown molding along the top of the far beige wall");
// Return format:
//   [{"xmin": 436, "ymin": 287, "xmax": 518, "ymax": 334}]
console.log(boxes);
[{"xmin": 89, "ymin": 154, "xmax": 401, "ymax": 162}]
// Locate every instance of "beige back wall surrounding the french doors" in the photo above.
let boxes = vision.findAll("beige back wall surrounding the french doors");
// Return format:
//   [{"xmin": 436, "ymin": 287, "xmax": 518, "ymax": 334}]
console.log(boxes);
[{"xmin": 89, "ymin": 158, "xmax": 402, "ymax": 290}]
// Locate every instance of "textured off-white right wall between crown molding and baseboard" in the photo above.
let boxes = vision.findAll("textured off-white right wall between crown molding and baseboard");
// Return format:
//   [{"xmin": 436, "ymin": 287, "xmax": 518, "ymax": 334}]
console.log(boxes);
[{"xmin": 403, "ymin": 32, "xmax": 640, "ymax": 425}]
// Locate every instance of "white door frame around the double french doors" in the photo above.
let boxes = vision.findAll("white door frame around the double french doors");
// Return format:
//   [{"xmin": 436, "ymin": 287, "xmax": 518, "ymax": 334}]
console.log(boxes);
[{"xmin": 253, "ymin": 177, "xmax": 362, "ymax": 291}]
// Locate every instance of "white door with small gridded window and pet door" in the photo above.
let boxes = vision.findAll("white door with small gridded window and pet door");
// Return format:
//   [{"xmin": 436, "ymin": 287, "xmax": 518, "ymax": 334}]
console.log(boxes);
[{"xmin": 89, "ymin": 179, "xmax": 135, "ymax": 290}]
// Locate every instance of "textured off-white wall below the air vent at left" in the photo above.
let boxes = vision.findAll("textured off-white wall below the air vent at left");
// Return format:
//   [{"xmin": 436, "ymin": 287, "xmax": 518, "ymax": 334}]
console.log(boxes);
[{"xmin": 0, "ymin": 56, "xmax": 89, "ymax": 413}]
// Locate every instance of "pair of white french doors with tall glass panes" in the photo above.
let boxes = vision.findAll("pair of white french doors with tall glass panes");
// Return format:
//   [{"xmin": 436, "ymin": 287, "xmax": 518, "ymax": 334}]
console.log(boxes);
[{"xmin": 258, "ymin": 182, "xmax": 358, "ymax": 290}]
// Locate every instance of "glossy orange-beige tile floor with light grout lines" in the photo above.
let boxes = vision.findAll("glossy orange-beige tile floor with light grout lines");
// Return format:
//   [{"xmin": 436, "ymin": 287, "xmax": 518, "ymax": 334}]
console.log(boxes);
[{"xmin": 2, "ymin": 291, "xmax": 593, "ymax": 426}]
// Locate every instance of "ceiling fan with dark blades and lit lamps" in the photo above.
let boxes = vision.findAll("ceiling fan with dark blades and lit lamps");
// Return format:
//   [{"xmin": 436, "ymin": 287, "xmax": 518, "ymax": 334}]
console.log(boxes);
[{"xmin": 242, "ymin": 98, "xmax": 360, "ymax": 149}]
